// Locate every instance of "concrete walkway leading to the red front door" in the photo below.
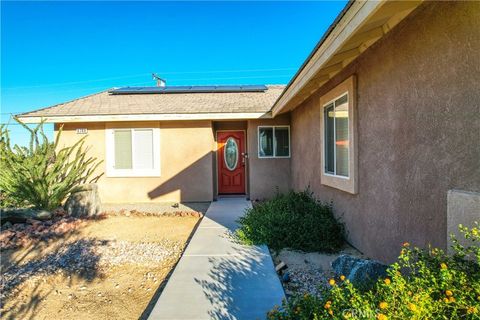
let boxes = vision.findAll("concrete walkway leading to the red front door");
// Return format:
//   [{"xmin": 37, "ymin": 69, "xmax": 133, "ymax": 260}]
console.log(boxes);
[{"xmin": 149, "ymin": 198, "xmax": 284, "ymax": 320}]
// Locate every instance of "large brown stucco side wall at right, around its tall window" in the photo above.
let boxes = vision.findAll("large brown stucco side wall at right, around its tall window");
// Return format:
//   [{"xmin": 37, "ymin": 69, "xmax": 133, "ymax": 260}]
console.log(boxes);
[{"xmin": 291, "ymin": 1, "xmax": 480, "ymax": 262}]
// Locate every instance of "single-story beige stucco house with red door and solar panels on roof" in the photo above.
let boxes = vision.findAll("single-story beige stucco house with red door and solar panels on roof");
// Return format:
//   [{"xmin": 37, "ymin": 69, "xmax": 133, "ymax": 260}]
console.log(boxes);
[{"xmin": 20, "ymin": 1, "xmax": 480, "ymax": 261}]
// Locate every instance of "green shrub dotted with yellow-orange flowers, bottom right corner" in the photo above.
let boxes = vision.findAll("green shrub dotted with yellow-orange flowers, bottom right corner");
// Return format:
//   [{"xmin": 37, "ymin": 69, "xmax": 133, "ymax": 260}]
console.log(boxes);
[{"xmin": 268, "ymin": 223, "xmax": 480, "ymax": 320}]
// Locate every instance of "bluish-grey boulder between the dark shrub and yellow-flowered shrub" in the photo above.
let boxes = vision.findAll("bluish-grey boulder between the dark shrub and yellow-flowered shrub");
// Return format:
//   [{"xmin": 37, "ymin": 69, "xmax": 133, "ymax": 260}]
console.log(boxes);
[{"xmin": 332, "ymin": 254, "xmax": 388, "ymax": 286}]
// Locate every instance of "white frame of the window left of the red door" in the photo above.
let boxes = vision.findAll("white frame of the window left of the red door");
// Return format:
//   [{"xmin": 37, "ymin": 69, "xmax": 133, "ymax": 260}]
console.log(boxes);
[{"xmin": 105, "ymin": 127, "xmax": 160, "ymax": 177}]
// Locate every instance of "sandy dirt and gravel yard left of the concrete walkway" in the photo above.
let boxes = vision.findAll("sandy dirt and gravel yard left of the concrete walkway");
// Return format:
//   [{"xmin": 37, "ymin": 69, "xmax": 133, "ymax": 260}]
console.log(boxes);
[{"xmin": 1, "ymin": 216, "xmax": 199, "ymax": 319}]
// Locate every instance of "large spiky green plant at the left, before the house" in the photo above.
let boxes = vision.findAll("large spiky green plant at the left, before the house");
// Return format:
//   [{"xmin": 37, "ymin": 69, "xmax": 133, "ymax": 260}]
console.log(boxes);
[{"xmin": 0, "ymin": 118, "xmax": 101, "ymax": 210}]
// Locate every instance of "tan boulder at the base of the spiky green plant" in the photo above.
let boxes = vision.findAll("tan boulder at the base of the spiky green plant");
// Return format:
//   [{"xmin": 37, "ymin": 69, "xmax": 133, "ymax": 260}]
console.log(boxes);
[{"xmin": 65, "ymin": 183, "xmax": 100, "ymax": 217}]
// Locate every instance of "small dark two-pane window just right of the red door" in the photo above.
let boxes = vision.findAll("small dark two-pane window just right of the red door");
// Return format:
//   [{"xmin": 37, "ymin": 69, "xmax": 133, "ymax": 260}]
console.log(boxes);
[{"xmin": 258, "ymin": 126, "xmax": 290, "ymax": 158}]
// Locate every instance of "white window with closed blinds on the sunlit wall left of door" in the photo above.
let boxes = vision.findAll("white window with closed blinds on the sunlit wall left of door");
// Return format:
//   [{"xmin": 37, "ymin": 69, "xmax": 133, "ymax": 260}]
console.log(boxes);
[{"xmin": 106, "ymin": 128, "xmax": 160, "ymax": 177}]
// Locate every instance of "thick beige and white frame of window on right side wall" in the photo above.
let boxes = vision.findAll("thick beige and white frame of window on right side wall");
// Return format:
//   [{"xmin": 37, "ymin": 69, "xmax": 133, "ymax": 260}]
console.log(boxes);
[{"xmin": 320, "ymin": 76, "xmax": 358, "ymax": 194}]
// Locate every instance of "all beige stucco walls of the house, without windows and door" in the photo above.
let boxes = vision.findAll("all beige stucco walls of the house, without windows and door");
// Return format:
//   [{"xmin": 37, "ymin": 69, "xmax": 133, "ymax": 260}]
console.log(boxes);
[{"xmin": 47, "ymin": 1, "xmax": 480, "ymax": 262}]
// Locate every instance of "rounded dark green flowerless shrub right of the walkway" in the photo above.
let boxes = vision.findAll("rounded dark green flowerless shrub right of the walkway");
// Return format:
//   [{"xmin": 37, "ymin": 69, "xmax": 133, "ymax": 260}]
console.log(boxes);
[{"xmin": 237, "ymin": 189, "xmax": 344, "ymax": 252}]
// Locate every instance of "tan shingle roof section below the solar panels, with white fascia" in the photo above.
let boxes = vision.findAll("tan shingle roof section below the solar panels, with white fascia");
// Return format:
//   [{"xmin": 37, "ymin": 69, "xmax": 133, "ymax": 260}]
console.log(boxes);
[{"xmin": 18, "ymin": 85, "xmax": 285, "ymax": 122}]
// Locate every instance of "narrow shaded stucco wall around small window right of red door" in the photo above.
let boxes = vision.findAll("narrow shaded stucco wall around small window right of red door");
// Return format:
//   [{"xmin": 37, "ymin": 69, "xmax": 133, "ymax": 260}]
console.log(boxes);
[{"xmin": 247, "ymin": 115, "xmax": 292, "ymax": 200}]
